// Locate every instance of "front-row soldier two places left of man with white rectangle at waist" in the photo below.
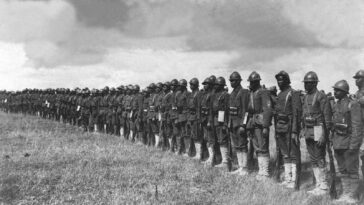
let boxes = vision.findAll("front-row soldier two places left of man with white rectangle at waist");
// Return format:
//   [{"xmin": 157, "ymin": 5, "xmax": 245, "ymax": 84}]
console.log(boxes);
[{"xmin": 186, "ymin": 78, "xmax": 202, "ymax": 160}]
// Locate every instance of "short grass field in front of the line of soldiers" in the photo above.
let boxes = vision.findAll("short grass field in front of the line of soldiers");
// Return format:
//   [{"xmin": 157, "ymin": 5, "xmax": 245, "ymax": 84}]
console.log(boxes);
[{"xmin": 0, "ymin": 113, "xmax": 362, "ymax": 205}]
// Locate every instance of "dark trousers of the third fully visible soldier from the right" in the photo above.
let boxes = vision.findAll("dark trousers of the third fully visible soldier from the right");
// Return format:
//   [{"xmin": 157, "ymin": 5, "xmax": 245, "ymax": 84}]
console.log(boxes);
[{"xmin": 276, "ymin": 133, "xmax": 298, "ymax": 164}]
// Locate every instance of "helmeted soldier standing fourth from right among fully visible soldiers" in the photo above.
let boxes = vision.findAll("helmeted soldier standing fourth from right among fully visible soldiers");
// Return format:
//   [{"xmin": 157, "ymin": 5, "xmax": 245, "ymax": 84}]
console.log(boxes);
[{"xmin": 247, "ymin": 71, "xmax": 272, "ymax": 180}]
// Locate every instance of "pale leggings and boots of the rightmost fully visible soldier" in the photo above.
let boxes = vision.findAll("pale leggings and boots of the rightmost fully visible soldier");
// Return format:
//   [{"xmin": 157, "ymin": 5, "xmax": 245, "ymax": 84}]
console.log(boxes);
[{"xmin": 336, "ymin": 177, "xmax": 359, "ymax": 204}]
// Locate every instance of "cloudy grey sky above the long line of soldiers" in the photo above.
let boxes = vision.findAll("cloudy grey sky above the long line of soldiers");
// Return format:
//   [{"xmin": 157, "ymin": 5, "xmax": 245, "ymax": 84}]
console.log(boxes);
[{"xmin": 0, "ymin": 0, "xmax": 364, "ymax": 92}]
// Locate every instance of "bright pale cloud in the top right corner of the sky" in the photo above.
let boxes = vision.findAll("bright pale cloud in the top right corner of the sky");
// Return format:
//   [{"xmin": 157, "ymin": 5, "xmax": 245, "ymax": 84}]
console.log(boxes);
[{"xmin": 282, "ymin": 0, "xmax": 364, "ymax": 48}]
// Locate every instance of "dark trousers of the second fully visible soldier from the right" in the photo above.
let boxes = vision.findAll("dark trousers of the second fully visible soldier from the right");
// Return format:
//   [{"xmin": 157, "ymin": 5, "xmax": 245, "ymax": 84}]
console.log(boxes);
[{"xmin": 306, "ymin": 138, "xmax": 326, "ymax": 168}]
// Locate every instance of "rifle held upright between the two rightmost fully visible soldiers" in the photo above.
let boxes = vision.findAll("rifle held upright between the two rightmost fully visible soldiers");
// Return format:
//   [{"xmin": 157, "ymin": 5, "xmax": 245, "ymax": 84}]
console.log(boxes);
[{"xmin": 321, "ymin": 112, "xmax": 337, "ymax": 199}]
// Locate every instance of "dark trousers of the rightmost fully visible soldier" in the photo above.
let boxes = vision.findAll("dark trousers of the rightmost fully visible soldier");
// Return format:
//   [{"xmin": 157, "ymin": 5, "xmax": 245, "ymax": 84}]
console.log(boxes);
[{"xmin": 334, "ymin": 149, "xmax": 359, "ymax": 178}]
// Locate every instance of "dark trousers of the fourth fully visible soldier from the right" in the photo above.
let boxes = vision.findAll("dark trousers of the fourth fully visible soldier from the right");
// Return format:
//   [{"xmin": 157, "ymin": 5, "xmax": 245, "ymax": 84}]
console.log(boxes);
[{"xmin": 251, "ymin": 127, "xmax": 269, "ymax": 157}]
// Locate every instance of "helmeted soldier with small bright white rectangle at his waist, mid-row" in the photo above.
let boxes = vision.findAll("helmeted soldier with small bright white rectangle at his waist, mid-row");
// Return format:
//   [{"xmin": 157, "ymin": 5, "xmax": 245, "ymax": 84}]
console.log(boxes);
[{"xmin": 210, "ymin": 77, "xmax": 231, "ymax": 169}]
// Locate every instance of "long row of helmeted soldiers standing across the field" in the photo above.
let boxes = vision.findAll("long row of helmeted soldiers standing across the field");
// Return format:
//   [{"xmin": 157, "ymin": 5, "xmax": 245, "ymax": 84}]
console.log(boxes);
[{"xmin": 0, "ymin": 70, "xmax": 364, "ymax": 203}]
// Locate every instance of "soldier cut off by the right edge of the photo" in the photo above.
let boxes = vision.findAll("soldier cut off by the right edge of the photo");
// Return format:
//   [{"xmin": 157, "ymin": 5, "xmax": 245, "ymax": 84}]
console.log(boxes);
[{"xmin": 354, "ymin": 70, "xmax": 364, "ymax": 181}]
